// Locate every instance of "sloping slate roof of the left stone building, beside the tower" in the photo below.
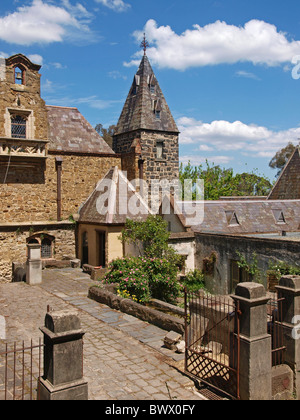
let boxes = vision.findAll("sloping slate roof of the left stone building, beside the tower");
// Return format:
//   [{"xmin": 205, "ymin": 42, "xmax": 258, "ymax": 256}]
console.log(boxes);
[{"xmin": 46, "ymin": 105, "xmax": 114, "ymax": 154}]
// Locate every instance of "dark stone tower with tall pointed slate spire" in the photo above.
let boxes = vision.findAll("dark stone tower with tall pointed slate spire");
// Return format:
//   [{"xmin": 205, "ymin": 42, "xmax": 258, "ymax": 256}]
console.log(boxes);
[{"xmin": 113, "ymin": 54, "xmax": 179, "ymax": 209}]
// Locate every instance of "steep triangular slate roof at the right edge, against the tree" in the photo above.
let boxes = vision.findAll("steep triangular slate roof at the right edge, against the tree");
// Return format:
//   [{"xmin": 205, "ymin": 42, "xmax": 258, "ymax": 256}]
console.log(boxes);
[{"xmin": 268, "ymin": 146, "xmax": 300, "ymax": 200}]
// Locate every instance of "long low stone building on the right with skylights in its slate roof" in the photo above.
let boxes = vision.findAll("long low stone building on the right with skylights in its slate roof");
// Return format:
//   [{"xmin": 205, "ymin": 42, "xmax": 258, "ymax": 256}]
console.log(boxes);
[{"xmin": 162, "ymin": 147, "xmax": 300, "ymax": 294}]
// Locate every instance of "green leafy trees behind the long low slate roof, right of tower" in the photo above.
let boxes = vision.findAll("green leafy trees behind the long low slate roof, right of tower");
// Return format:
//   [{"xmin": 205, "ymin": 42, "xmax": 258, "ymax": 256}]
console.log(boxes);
[{"xmin": 179, "ymin": 161, "xmax": 272, "ymax": 200}]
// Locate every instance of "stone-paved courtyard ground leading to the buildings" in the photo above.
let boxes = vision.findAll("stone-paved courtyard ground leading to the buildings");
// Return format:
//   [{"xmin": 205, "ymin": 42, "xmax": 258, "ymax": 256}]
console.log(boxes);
[{"xmin": 0, "ymin": 269, "xmax": 205, "ymax": 401}]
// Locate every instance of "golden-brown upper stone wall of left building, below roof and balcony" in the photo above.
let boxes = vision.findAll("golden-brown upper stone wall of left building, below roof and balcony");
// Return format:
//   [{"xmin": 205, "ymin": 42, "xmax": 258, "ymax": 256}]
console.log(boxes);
[{"xmin": 0, "ymin": 154, "xmax": 120, "ymax": 223}]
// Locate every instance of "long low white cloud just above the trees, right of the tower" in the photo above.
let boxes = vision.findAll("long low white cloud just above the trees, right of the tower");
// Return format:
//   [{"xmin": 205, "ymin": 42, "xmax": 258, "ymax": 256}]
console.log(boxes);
[{"xmin": 177, "ymin": 117, "xmax": 300, "ymax": 158}]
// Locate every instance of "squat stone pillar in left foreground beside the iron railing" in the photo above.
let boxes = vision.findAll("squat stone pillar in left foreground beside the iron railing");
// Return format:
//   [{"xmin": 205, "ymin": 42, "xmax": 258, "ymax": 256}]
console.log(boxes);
[{"xmin": 38, "ymin": 311, "xmax": 88, "ymax": 401}]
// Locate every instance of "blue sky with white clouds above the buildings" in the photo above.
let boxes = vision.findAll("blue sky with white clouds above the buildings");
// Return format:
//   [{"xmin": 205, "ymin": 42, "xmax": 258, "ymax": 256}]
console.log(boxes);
[{"xmin": 0, "ymin": 0, "xmax": 300, "ymax": 179}]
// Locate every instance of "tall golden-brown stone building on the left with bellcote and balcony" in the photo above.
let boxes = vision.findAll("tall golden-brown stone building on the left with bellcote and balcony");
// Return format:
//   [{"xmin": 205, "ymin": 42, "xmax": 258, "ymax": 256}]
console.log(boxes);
[{"xmin": 0, "ymin": 54, "xmax": 121, "ymax": 282}]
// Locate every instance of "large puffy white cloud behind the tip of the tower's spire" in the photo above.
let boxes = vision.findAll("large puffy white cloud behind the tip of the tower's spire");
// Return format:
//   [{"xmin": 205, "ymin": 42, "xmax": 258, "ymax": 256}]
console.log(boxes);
[{"xmin": 124, "ymin": 19, "xmax": 300, "ymax": 70}]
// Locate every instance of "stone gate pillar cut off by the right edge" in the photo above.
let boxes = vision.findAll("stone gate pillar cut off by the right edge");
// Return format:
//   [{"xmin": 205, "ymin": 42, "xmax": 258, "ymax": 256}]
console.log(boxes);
[{"xmin": 276, "ymin": 276, "xmax": 300, "ymax": 399}]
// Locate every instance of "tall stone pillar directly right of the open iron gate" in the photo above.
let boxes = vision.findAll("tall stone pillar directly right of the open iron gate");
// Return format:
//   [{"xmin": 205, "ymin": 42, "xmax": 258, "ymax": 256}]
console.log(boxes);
[{"xmin": 232, "ymin": 283, "xmax": 272, "ymax": 400}]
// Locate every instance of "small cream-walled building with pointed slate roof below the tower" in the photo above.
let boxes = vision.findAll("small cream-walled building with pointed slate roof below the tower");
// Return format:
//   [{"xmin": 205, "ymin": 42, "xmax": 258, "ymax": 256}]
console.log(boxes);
[{"xmin": 78, "ymin": 166, "xmax": 151, "ymax": 267}]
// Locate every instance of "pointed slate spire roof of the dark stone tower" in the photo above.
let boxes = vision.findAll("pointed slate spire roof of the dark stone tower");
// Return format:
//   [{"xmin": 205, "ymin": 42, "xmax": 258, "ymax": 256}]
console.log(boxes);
[{"xmin": 115, "ymin": 55, "xmax": 179, "ymax": 135}]
